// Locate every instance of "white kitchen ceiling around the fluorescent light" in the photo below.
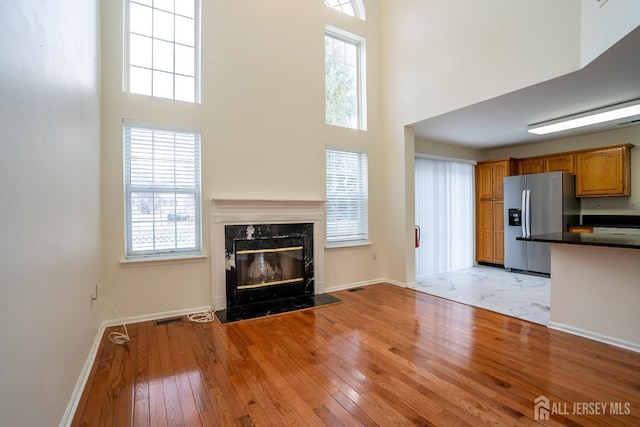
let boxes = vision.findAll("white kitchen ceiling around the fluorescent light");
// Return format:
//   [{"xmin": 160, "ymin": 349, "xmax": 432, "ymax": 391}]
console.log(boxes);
[{"xmin": 413, "ymin": 27, "xmax": 640, "ymax": 148}]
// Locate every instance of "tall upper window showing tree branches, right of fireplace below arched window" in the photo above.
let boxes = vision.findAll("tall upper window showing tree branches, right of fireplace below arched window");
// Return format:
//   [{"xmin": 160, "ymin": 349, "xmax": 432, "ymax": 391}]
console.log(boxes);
[{"xmin": 324, "ymin": 27, "xmax": 366, "ymax": 130}]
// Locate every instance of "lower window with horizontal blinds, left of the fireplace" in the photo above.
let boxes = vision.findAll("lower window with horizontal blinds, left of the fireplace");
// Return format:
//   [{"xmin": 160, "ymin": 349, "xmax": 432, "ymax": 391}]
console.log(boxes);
[{"xmin": 123, "ymin": 121, "xmax": 202, "ymax": 259}]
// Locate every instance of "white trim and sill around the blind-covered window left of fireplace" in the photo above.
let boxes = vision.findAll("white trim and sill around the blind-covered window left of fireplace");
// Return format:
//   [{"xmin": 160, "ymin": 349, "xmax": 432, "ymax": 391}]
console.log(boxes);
[{"xmin": 120, "ymin": 119, "xmax": 202, "ymax": 265}]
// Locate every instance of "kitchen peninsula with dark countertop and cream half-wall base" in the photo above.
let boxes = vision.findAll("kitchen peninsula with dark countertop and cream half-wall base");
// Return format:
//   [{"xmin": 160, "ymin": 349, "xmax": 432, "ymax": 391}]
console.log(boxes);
[{"xmin": 518, "ymin": 233, "xmax": 640, "ymax": 352}]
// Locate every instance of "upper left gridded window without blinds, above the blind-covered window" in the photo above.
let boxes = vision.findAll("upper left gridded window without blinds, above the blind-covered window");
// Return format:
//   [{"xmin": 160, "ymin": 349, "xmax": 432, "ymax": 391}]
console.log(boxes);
[{"xmin": 124, "ymin": 0, "xmax": 200, "ymax": 102}]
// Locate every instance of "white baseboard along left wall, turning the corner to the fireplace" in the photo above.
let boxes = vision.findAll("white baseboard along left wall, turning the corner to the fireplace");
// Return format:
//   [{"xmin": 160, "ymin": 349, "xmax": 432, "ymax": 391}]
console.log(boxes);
[{"xmin": 60, "ymin": 306, "xmax": 211, "ymax": 427}]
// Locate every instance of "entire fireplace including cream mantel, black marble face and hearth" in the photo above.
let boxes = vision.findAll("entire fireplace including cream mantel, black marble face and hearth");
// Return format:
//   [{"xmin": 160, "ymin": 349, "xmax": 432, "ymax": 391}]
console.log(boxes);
[{"xmin": 210, "ymin": 199, "xmax": 337, "ymax": 323}]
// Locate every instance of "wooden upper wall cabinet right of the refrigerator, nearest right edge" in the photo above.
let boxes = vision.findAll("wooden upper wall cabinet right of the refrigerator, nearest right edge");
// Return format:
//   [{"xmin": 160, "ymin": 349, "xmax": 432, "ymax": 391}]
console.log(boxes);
[{"xmin": 576, "ymin": 144, "xmax": 633, "ymax": 197}]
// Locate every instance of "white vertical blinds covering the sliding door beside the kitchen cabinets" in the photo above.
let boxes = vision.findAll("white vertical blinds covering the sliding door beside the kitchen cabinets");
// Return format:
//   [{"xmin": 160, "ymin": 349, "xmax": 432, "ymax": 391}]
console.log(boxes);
[{"xmin": 415, "ymin": 157, "xmax": 474, "ymax": 278}]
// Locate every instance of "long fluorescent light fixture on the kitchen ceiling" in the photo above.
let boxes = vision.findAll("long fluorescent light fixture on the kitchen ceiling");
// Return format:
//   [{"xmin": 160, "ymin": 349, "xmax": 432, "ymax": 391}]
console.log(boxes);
[{"xmin": 528, "ymin": 99, "xmax": 640, "ymax": 135}]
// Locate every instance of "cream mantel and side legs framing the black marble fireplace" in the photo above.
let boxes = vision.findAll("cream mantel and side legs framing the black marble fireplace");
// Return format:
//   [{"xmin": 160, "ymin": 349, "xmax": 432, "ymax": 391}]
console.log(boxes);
[{"xmin": 210, "ymin": 199, "xmax": 326, "ymax": 310}]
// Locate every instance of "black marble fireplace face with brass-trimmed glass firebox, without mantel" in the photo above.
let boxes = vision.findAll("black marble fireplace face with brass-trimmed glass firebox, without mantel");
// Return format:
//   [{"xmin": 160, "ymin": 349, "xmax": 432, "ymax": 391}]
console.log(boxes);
[{"xmin": 225, "ymin": 223, "xmax": 314, "ymax": 308}]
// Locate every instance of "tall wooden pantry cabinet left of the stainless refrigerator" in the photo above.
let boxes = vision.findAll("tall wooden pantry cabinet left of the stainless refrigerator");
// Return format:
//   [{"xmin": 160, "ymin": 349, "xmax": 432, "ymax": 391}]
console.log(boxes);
[{"xmin": 476, "ymin": 158, "xmax": 518, "ymax": 264}]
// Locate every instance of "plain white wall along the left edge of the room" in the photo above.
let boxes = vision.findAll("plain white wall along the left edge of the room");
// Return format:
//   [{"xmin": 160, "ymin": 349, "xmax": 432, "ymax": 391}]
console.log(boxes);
[{"xmin": 0, "ymin": 0, "xmax": 100, "ymax": 426}]
